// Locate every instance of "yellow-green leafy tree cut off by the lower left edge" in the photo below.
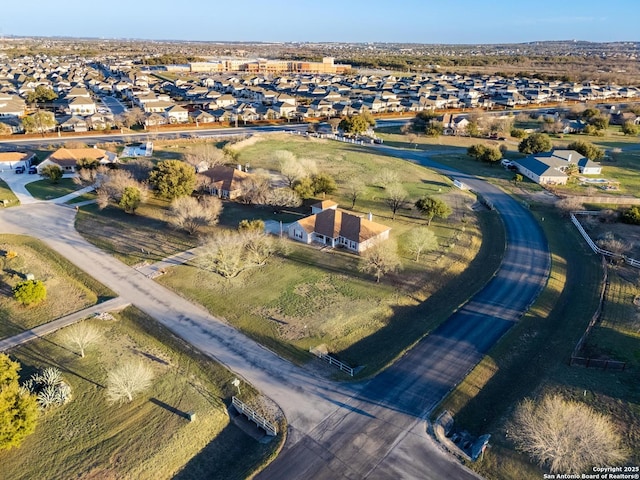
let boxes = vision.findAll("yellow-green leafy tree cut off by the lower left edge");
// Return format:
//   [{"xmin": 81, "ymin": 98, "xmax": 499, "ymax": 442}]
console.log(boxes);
[{"xmin": 0, "ymin": 353, "xmax": 38, "ymax": 450}]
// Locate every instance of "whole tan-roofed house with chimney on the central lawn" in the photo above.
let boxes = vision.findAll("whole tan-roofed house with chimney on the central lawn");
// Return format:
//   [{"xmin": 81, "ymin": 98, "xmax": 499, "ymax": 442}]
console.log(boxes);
[{"xmin": 287, "ymin": 201, "xmax": 391, "ymax": 253}]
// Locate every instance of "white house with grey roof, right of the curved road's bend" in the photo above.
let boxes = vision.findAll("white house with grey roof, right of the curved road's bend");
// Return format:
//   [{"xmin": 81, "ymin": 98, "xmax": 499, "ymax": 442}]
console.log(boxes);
[{"xmin": 513, "ymin": 150, "xmax": 602, "ymax": 185}]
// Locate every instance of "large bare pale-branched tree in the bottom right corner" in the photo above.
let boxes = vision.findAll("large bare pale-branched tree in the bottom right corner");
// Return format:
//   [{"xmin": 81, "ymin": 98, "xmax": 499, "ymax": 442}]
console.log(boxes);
[{"xmin": 509, "ymin": 395, "xmax": 625, "ymax": 473}]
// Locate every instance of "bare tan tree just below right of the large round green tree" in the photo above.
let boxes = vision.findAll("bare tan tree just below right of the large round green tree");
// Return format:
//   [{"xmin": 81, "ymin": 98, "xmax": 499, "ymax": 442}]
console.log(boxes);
[{"xmin": 168, "ymin": 196, "xmax": 222, "ymax": 235}]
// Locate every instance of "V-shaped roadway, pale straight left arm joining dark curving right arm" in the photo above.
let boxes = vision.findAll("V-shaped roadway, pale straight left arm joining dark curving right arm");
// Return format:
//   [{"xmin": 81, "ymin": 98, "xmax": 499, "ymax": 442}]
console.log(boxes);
[{"xmin": 0, "ymin": 147, "xmax": 549, "ymax": 479}]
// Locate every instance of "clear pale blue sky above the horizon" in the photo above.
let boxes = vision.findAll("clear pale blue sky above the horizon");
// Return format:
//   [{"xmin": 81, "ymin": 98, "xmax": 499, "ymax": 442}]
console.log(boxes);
[{"xmin": 0, "ymin": 0, "xmax": 640, "ymax": 44}]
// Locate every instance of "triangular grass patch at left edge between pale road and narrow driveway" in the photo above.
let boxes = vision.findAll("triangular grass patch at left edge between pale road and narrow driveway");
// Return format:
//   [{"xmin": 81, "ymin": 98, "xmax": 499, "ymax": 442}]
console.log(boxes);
[{"xmin": 0, "ymin": 235, "xmax": 115, "ymax": 338}]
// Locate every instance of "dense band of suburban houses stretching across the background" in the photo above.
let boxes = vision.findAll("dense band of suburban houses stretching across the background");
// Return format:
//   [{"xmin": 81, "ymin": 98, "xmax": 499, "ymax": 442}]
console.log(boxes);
[{"xmin": 0, "ymin": 52, "xmax": 640, "ymax": 133}]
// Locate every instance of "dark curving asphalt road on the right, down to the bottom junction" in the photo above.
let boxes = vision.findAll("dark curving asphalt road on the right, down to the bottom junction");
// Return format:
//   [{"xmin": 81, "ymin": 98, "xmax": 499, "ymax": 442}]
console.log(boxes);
[{"xmin": 257, "ymin": 147, "xmax": 550, "ymax": 480}]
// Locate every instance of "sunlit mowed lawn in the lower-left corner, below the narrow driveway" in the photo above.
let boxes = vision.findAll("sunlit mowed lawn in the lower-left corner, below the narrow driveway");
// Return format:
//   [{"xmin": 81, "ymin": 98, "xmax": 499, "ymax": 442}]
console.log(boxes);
[{"xmin": 0, "ymin": 308, "xmax": 281, "ymax": 480}]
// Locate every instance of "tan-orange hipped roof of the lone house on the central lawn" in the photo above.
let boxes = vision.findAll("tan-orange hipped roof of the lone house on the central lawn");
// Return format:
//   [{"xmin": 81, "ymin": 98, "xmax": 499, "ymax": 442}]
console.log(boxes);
[{"xmin": 298, "ymin": 208, "xmax": 391, "ymax": 243}]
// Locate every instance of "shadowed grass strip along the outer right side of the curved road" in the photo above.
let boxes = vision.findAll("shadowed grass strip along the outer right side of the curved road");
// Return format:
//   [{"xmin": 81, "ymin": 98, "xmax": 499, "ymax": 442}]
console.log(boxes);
[{"xmin": 433, "ymin": 206, "xmax": 640, "ymax": 480}]
